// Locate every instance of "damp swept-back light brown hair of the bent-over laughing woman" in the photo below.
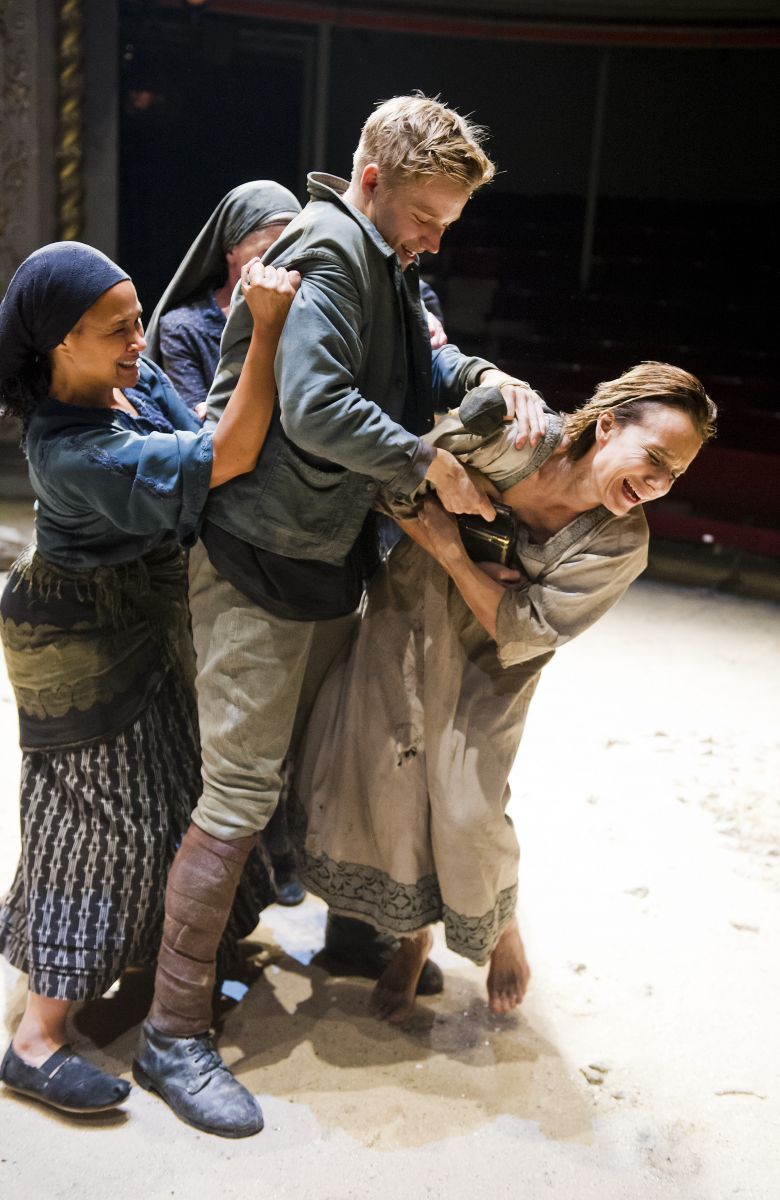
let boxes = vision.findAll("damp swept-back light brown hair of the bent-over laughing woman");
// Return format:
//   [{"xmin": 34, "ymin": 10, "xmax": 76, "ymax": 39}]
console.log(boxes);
[{"xmin": 564, "ymin": 362, "xmax": 718, "ymax": 460}]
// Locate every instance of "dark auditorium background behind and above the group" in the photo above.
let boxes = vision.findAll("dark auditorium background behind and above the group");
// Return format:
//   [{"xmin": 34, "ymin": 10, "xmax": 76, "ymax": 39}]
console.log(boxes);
[{"xmin": 0, "ymin": 0, "xmax": 780, "ymax": 599}]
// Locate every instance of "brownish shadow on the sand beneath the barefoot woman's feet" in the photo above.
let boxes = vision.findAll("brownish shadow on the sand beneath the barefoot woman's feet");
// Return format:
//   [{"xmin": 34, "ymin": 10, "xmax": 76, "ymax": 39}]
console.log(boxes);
[{"xmin": 66, "ymin": 929, "xmax": 585, "ymax": 1150}]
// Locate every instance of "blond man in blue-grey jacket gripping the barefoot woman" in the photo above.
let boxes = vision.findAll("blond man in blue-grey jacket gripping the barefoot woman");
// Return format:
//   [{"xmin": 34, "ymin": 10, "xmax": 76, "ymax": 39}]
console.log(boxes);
[{"xmin": 136, "ymin": 96, "xmax": 542, "ymax": 1138}]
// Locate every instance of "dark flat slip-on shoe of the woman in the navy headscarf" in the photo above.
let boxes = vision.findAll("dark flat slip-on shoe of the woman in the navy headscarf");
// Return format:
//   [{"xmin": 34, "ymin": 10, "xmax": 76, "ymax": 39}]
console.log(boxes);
[{"xmin": 0, "ymin": 1045, "xmax": 130, "ymax": 1112}]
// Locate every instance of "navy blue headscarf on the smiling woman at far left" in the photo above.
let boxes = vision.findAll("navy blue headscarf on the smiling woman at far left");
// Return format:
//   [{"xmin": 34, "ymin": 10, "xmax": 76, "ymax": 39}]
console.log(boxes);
[{"xmin": 0, "ymin": 241, "xmax": 130, "ymax": 379}]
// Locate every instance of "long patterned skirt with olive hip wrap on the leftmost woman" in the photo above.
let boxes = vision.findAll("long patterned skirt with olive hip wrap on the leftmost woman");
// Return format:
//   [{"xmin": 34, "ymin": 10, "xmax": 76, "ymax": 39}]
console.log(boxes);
[{"xmin": 0, "ymin": 542, "xmax": 274, "ymax": 1001}]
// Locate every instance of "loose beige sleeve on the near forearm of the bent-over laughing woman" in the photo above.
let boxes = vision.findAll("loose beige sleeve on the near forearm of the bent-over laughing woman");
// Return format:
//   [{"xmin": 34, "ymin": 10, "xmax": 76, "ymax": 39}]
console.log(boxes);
[{"xmin": 496, "ymin": 509, "xmax": 648, "ymax": 667}]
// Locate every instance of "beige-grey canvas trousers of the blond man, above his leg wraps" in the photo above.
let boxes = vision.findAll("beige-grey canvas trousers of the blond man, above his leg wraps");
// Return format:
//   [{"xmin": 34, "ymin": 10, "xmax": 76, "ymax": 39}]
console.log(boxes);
[{"xmin": 190, "ymin": 542, "xmax": 356, "ymax": 841}]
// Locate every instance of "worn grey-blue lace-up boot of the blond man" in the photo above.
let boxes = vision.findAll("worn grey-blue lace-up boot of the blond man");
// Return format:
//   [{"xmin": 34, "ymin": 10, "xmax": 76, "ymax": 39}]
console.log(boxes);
[{"xmin": 133, "ymin": 1021, "xmax": 263, "ymax": 1138}]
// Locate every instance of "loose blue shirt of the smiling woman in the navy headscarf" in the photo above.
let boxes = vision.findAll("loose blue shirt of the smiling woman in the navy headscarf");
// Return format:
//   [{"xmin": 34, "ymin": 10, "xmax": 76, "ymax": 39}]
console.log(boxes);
[{"xmin": 26, "ymin": 359, "xmax": 211, "ymax": 568}]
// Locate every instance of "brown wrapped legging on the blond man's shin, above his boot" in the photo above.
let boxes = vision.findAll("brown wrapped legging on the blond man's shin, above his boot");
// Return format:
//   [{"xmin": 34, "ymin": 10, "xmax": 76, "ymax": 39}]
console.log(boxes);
[{"xmin": 149, "ymin": 824, "xmax": 257, "ymax": 1037}]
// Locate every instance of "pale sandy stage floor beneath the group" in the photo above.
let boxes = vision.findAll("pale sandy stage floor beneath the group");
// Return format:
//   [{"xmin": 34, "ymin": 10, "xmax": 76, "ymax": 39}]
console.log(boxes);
[{"xmin": 0, "ymin": 583, "xmax": 780, "ymax": 1200}]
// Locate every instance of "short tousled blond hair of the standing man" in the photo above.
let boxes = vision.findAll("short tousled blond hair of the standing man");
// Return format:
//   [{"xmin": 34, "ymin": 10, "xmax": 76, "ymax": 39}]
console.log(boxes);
[{"xmin": 353, "ymin": 94, "xmax": 496, "ymax": 192}]
